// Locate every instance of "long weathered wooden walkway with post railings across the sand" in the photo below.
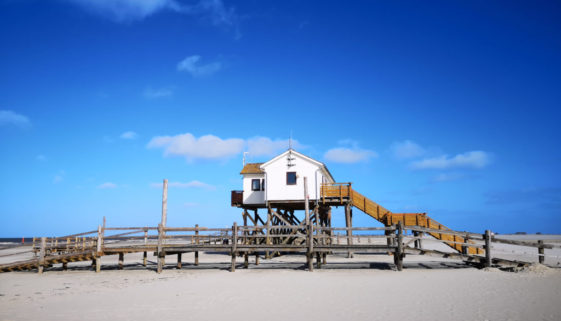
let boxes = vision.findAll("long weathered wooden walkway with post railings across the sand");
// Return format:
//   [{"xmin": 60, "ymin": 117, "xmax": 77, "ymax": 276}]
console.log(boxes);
[{"xmin": 0, "ymin": 222, "xmax": 561, "ymax": 273}]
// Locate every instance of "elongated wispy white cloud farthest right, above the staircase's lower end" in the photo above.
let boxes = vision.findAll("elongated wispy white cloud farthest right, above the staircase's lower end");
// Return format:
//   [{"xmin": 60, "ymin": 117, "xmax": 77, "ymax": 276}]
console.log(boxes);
[{"xmin": 411, "ymin": 151, "xmax": 491, "ymax": 169}]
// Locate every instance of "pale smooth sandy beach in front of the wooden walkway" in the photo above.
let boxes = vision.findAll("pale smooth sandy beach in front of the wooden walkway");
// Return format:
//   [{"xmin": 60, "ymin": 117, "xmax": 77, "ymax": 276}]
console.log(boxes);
[{"xmin": 0, "ymin": 235, "xmax": 561, "ymax": 320}]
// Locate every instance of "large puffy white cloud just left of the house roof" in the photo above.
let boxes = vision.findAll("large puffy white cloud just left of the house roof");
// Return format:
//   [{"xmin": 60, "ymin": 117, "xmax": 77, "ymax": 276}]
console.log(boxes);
[{"xmin": 147, "ymin": 133, "xmax": 244, "ymax": 161}]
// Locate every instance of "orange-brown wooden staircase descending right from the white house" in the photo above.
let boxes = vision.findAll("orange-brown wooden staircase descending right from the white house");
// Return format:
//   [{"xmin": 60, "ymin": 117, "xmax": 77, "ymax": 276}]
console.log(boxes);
[{"xmin": 321, "ymin": 183, "xmax": 484, "ymax": 254}]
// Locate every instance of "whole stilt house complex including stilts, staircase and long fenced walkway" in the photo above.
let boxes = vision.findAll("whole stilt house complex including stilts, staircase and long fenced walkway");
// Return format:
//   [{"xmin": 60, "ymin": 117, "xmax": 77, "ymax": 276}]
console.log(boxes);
[{"xmin": 0, "ymin": 148, "xmax": 559, "ymax": 273}]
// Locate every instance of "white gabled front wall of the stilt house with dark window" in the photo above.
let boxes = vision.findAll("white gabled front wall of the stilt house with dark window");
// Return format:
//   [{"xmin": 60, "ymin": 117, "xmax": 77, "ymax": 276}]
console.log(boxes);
[{"xmin": 264, "ymin": 154, "xmax": 323, "ymax": 201}]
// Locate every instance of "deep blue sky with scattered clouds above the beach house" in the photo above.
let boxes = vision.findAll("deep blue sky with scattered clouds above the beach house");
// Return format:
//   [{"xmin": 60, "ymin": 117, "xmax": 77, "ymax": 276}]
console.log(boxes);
[{"xmin": 0, "ymin": 0, "xmax": 561, "ymax": 237}]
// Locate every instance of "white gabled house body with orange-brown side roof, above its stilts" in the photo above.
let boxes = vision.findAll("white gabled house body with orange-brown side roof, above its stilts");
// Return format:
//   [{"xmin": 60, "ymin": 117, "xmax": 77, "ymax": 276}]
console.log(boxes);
[{"xmin": 232, "ymin": 149, "xmax": 335, "ymax": 208}]
